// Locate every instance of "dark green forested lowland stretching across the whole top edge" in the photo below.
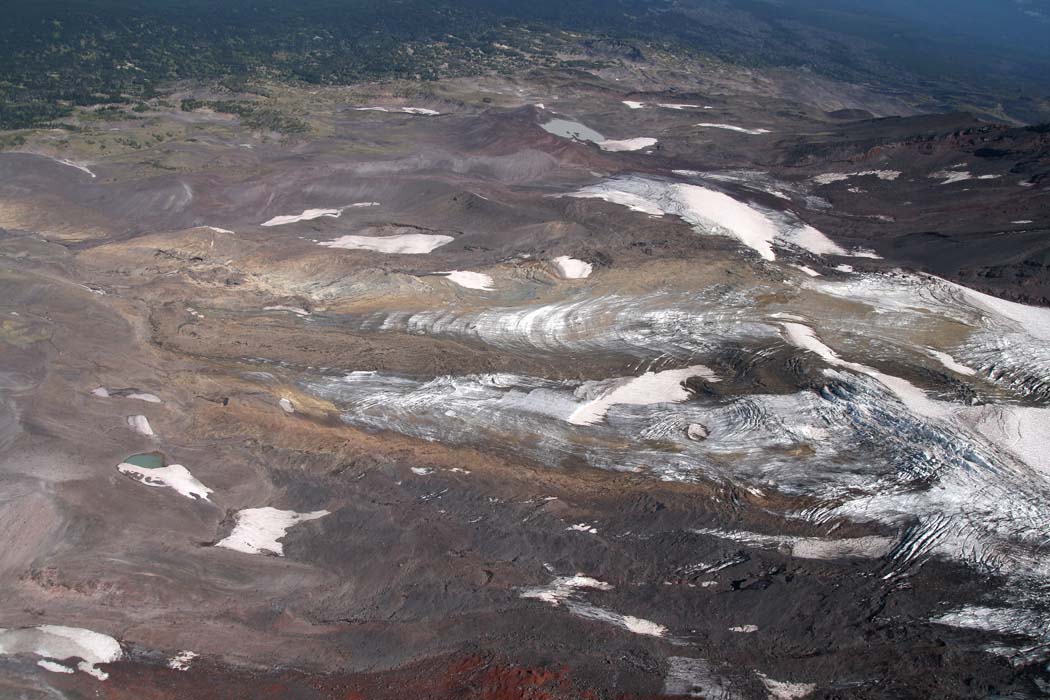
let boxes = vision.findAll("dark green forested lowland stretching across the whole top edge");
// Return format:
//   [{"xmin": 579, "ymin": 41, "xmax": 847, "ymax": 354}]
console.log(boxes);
[{"xmin": 0, "ymin": 0, "xmax": 1050, "ymax": 132}]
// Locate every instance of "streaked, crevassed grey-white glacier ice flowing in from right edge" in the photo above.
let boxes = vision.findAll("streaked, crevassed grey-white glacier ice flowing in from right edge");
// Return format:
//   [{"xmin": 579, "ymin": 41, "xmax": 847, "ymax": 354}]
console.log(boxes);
[{"xmin": 289, "ymin": 228, "xmax": 1050, "ymax": 646}]
